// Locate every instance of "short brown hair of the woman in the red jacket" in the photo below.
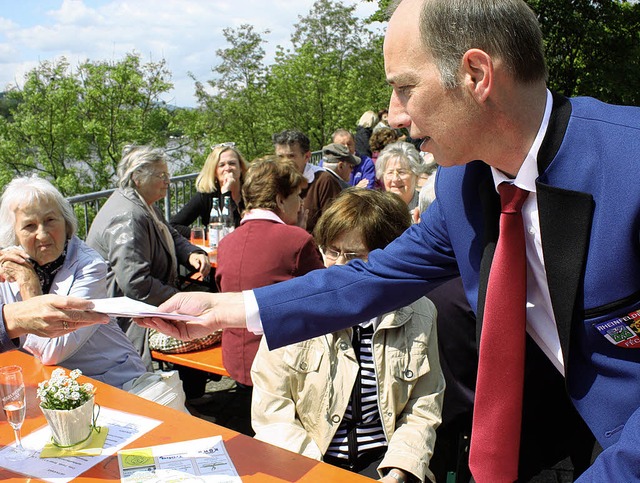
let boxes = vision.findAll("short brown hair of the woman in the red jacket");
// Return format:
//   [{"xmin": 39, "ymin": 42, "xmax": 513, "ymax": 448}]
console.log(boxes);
[{"xmin": 242, "ymin": 156, "xmax": 306, "ymax": 211}]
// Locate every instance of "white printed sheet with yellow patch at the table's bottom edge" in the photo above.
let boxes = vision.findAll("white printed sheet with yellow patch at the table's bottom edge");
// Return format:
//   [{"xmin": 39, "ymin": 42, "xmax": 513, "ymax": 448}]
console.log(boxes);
[{"xmin": 118, "ymin": 436, "xmax": 242, "ymax": 483}]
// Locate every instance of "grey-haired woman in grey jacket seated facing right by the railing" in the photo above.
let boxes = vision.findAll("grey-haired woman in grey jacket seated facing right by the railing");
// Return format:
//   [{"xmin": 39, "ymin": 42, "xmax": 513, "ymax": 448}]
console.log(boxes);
[{"xmin": 87, "ymin": 146, "xmax": 211, "ymax": 372}]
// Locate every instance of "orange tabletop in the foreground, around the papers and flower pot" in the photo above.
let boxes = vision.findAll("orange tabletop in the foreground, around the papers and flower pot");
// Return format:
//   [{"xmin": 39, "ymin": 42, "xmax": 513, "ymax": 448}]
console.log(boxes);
[{"xmin": 0, "ymin": 351, "xmax": 373, "ymax": 483}]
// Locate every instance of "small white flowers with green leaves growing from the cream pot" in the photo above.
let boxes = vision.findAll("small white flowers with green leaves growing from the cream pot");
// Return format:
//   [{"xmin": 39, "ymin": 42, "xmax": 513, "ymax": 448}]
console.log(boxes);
[{"xmin": 37, "ymin": 368, "xmax": 95, "ymax": 410}]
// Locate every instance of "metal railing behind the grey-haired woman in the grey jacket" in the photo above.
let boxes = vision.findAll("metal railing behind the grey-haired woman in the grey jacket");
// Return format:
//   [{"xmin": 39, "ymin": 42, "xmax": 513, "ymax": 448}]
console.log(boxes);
[{"xmin": 67, "ymin": 173, "xmax": 198, "ymax": 239}]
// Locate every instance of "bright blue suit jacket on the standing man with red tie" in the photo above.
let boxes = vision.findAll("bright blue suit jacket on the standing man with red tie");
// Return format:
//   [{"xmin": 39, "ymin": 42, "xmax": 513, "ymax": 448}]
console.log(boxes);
[{"xmin": 255, "ymin": 96, "xmax": 640, "ymax": 481}]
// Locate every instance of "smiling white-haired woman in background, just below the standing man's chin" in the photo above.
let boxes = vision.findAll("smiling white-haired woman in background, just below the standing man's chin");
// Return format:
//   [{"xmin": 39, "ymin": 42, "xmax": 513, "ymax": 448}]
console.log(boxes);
[{"xmin": 376, "ymin": 141, "xmax": 423, "ymax": 223}]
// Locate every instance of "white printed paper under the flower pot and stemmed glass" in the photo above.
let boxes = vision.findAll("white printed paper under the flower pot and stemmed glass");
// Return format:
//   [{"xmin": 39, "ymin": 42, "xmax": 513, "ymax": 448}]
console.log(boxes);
[{"xmin": 0, "ymin": 407, "xmax": 162, "ymax": 483}]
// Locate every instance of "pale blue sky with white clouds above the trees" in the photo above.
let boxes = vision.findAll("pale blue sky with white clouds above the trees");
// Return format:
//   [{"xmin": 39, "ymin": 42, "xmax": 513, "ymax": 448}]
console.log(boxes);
[{"xmin": 0, "ymin": 0, "xmax": 377, "ymax": 106}]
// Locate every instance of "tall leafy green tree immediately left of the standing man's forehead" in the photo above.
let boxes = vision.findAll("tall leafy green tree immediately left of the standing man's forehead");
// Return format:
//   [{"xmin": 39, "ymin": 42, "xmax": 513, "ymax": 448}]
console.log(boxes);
[{"xmin": 269, "ymin": 0, "xmax": 388, "ymax": 149}]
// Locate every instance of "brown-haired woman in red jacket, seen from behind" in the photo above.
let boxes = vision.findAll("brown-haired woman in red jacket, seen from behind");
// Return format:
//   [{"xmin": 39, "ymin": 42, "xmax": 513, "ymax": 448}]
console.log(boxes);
[{"xmin": 216, "ymin": 157, "xmax": 324, "ymax": 386}]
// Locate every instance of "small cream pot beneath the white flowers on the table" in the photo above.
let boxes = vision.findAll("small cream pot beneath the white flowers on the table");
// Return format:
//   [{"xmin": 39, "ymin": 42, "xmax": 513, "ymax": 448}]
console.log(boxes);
[{"xmin": 40, "ymin": 397, "xmax": 94, "ymax": 446}]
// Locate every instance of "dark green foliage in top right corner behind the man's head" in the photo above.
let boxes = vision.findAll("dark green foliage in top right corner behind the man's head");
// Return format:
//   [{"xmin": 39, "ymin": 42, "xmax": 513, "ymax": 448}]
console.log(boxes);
[{"xmin": 527, "ymin": 0, "xmax": 640, "ymax": 105}]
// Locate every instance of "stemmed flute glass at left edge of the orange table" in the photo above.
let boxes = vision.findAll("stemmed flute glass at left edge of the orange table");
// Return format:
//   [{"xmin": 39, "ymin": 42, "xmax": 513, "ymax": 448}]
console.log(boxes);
[{"xmin": 0, "ymin": 366, "xmax": 29, "ymax": 461}]
